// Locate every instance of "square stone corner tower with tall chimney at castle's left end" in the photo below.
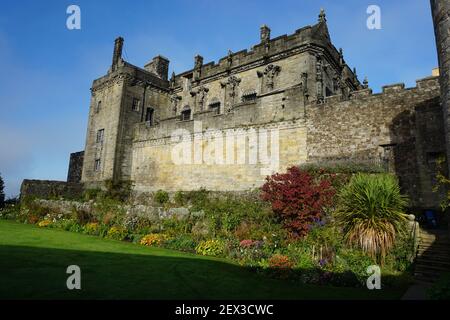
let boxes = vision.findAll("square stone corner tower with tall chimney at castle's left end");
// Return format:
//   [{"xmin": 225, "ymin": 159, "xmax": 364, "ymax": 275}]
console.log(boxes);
[{"xmin": 81, "ymin": 37, "xmax": 137, "ymax": 187}]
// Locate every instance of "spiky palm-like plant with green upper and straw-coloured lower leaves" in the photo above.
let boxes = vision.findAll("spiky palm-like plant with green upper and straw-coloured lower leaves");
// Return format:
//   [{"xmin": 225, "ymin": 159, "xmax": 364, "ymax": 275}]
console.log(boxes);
[{"xmin": 335, "ymin": 173, "xmax": 408, "ymax": 263}]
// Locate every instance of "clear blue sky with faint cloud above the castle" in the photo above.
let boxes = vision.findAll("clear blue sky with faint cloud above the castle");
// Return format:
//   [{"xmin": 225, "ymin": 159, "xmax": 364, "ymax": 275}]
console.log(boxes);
[{"xmin": 0, "ymin": 0, "xmax": 437, "ymax": 196}]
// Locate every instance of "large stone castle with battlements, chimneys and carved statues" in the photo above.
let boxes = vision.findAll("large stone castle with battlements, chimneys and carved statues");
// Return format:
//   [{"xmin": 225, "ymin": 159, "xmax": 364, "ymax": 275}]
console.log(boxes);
[{"xmin": 24, "ymin": 6, "xmax": 448, "ymax": 207}]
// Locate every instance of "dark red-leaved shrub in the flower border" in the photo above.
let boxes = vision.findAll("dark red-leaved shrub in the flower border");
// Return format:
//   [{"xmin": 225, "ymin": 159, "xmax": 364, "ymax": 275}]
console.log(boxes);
[{"xmin": 262, "ymin": 167, "xmax": 334, "ymax": 237}]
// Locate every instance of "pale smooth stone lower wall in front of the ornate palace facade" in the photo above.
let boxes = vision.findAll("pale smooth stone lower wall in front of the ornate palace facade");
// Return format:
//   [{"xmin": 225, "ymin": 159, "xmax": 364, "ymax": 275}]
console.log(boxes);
[{"xmin": 131, "ymin": 86, "xmax": 306, "ymax": 191}]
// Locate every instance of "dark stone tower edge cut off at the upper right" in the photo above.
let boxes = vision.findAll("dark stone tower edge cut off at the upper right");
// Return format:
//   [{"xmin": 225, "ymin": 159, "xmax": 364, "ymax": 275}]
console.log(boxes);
[{"xmin": 431, "ymin": 0, "xmax": 450, "ymax": 172}]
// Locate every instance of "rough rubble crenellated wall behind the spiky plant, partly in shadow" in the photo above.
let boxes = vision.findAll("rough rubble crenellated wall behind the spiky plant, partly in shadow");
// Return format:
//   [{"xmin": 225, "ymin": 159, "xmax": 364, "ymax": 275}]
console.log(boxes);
[{"xmin": 306, "ymin": 77, "xmax": 445, "ymax": 207}]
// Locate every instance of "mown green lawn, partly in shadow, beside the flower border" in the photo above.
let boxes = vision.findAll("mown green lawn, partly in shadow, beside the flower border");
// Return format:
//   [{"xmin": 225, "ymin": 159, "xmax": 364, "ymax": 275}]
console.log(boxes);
[{"xmin": 0, "ymin": 220, "xmax": 403, "ymax": 299}]
